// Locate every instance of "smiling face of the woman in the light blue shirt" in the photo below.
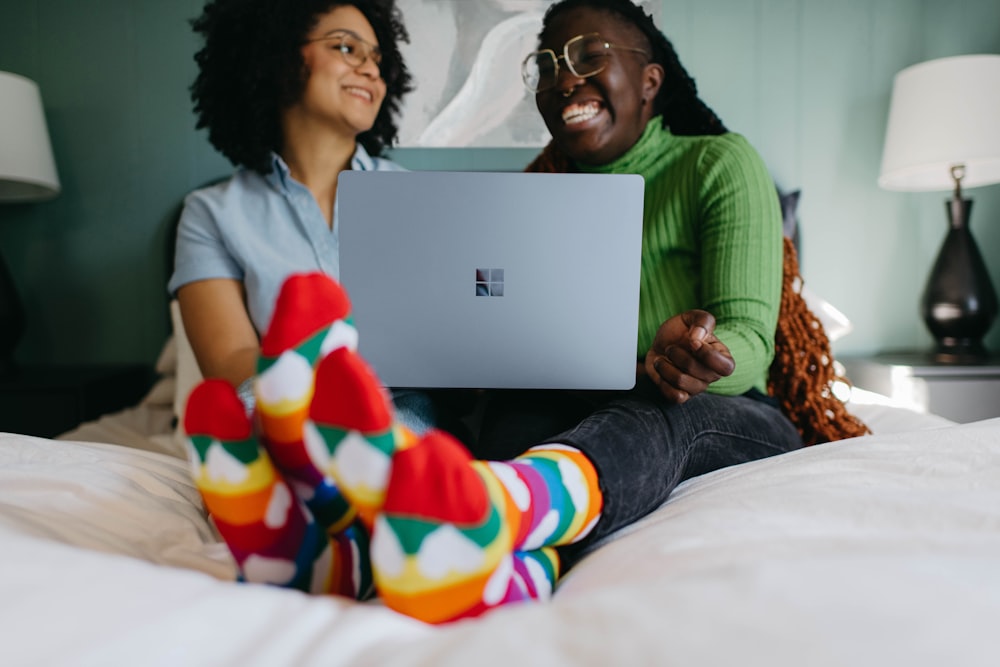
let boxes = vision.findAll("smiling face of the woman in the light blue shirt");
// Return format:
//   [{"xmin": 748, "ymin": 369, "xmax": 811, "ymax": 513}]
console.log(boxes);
[{"xmin": 289, "ymin": 5, "xmax": 386, "ymax": 139}]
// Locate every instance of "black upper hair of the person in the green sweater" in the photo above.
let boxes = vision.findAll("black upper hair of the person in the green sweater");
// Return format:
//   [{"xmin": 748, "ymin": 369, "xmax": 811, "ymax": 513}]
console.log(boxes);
[{"xmin": 538, "ymin": 0, "xmax": 727, "ymax": 135}]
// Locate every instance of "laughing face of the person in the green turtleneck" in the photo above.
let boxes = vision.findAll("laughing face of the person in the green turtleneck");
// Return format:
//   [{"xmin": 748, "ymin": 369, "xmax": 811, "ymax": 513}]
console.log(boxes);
[{"xmin": 535, "ymin": 7, "xmax": 663, "ymax": 165}]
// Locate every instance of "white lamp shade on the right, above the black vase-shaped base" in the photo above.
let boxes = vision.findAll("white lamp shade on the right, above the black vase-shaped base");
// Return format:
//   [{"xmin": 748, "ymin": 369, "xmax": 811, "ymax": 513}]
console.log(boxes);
[{"xmin": 878, "ymin": 54, "xmax": 1000, "ymax": 190}]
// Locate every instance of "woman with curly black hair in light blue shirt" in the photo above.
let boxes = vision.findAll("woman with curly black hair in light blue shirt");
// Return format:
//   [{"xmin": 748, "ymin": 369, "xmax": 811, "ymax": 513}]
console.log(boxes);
[{"xmin": 168, "ymin": 2, "xmax": 428, "ymax": 430}]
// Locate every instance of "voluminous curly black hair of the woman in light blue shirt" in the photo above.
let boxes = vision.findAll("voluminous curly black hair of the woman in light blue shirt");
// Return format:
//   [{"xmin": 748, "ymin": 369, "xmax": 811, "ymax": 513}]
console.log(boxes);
[{"xmin": 191, "ymin": 0, "xmax": 413, "ymax": 174}]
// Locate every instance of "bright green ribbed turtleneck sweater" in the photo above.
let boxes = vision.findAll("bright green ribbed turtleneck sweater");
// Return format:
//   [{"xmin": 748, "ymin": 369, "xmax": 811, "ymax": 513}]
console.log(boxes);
[{"xmin": 577, "ymin": 116, "xmax": 782, "ymax": 395}]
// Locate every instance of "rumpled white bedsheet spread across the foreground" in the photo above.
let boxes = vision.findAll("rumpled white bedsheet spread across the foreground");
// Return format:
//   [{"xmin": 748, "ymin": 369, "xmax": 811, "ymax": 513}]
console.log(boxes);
[{"xmin": 0, "ymin": 407, "xmax": 1000, "ymax": 667}]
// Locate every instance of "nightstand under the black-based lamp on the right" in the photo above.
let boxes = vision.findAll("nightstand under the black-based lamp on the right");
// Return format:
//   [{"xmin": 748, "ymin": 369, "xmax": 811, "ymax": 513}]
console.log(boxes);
[{"xmin": 838, "ymin": 352, "xmax": 1000, "ymax": 422}]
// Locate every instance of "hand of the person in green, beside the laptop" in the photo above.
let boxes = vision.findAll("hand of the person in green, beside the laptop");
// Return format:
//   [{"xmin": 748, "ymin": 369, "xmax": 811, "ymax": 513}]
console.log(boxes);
[{"xmin": 643, "ymin": 310, "xmax": 736, "ymax": 403}]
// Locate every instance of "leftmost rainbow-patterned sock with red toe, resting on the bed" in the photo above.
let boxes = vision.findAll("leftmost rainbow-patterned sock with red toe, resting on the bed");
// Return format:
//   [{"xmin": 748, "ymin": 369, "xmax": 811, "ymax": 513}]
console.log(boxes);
[{"xmin": 184, "ymin": 379, "xmax": 371, "ymax": 598}]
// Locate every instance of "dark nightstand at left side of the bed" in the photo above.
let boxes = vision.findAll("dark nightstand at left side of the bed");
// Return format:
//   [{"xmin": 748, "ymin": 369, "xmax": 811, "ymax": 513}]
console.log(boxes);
[{"xmin": 0, "ymin": 364, "xmax": 155, "ymax": 438}]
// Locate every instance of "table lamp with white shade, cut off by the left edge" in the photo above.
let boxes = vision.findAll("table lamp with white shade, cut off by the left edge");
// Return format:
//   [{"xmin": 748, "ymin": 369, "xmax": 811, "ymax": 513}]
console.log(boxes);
[{"xmin": 0, "ymin": 72, "xmax": 59, "ymax": 375}]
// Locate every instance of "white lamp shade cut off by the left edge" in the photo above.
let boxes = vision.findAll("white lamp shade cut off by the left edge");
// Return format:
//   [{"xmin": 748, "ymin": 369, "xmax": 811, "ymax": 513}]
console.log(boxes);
[{"xmin": 0, "ymin": 72, "xmax": 60, "ymax": 201}]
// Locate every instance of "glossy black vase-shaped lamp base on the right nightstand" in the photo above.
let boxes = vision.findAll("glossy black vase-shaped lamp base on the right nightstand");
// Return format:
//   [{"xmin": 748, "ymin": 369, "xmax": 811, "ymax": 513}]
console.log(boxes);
[{"xmin": 921, "ymin": 196, "xmax": 997, "ymax": 364}]
